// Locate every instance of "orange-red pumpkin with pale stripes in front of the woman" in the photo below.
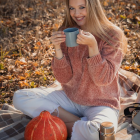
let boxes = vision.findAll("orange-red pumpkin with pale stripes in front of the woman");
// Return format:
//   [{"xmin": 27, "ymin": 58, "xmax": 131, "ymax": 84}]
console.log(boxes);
[{"xmin": 24, "ymin": 111, "xmax": 67, "ymax": 140}]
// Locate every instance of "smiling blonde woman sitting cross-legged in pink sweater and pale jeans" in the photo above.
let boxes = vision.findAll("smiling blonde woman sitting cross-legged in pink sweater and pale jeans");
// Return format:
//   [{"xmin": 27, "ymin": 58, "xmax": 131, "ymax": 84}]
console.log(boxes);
[{"xmin": 13, "ymin": 0, "xmax": 127, "ymax": 140}]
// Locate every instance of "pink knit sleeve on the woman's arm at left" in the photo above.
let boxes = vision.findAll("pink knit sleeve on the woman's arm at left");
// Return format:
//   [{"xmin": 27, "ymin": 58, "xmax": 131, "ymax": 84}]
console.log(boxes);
[{"xmin": 51, "ymin": 44, "xmax": 73, "ymax": 84}]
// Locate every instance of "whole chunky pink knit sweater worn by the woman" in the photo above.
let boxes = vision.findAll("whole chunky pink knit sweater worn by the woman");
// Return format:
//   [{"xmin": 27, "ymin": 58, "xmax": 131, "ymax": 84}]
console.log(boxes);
[{"xmin": 52, "ymin": 32, "xmax": 122, "ymax": 109}]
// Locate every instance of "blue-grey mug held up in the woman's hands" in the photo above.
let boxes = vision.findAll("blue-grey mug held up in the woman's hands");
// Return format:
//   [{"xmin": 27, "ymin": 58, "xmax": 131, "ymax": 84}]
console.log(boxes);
[{"xmin": 64, "ymin": 28, "xmax": 79, "ymax": 47}]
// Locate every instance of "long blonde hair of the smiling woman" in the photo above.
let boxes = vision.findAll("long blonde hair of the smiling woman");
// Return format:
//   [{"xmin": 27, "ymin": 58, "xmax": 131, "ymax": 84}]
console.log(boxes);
[{"xmin": 61, "ymin": 0, "xmax": 127, "ymax": 54}]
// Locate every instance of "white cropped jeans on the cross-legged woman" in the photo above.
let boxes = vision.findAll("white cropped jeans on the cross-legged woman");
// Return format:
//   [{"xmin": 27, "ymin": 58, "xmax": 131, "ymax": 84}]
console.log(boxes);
[{"xmin": 13, "ymin": 87, "xmax": 119, "ymax": 140}]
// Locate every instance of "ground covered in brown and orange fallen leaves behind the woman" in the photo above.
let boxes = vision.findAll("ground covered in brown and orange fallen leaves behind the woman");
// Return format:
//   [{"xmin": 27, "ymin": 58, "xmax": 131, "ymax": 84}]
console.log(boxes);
[{"xmin": 0, "ymin": 0, "xmax": 140, "ymax": 104}]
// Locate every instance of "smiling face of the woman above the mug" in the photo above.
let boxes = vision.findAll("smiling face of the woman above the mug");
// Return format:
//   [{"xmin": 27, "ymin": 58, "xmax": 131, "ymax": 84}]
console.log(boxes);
[{"xmin": 69, "ymin": 0, "xmax": 87, "ymax": 30}]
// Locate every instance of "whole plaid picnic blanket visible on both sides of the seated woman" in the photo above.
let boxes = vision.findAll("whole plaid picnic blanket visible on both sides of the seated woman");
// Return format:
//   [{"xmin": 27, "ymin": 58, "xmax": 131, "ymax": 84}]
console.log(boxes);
[{"xmin": 0, "ymin": 71, "xmax": 140, "ymax": 140}]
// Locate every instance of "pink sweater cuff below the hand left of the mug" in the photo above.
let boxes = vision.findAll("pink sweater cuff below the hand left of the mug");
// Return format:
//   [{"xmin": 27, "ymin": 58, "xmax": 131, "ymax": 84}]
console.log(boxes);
[{"xmin": 54, "ymin": 55, "xmax": 68, "ymax": 68}]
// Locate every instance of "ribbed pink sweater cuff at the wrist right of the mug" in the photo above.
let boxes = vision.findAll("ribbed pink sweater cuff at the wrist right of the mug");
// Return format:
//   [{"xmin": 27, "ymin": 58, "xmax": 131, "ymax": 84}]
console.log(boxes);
[{"xmin": 87, "ymin": 54, "xmax": 102, "ymax": 66}]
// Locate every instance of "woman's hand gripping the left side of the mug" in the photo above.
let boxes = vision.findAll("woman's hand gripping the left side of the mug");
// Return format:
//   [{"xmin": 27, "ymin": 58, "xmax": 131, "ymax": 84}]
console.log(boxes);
[{"xmin": 50, "ymin": 31, "xmax": 66, "ymax": 49}]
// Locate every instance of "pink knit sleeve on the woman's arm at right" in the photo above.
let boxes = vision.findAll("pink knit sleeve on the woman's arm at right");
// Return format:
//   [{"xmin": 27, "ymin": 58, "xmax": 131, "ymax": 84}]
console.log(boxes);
[{"xmin": 87, "ymin": 36, "xmax": 123, "ymax": 86}]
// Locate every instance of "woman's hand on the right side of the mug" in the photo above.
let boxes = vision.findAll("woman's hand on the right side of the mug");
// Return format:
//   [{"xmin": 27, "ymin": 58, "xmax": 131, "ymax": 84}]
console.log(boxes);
[{"xmin": 77, "ymin": 30, "xmax": 97, "ymax": 47}]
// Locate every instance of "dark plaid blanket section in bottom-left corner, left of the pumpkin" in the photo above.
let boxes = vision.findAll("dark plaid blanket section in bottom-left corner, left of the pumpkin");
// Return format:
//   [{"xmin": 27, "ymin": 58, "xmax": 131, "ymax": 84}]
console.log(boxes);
[{"xmin": 0, "ymin": 104, "xmax": 31, "ymax": 140}]
